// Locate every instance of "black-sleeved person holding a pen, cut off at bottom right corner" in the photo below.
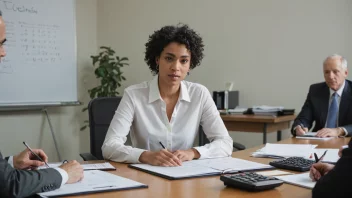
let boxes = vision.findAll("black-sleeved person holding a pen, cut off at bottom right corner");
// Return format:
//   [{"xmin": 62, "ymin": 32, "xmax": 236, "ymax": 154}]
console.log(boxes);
[{"xmin": 310, "ymin": 141, "xmax": 352, "ymax": 198}]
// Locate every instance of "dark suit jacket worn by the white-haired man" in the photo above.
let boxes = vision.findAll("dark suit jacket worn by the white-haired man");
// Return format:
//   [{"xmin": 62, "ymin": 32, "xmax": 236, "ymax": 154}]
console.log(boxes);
[{"xmin": 291, "ymin": 80, "xmax": 352, "ymax": 136}]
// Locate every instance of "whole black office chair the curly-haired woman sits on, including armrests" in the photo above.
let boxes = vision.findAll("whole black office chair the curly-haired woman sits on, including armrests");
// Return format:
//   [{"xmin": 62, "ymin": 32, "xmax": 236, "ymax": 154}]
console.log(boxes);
[{"xmin": 80, "ymin": 96, "xmax": 245, "ymax": 161}]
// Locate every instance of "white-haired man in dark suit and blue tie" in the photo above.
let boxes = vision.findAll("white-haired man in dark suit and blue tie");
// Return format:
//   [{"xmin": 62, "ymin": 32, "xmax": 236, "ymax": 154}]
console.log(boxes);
[{"xmin": 291, "ymin": 54, "xmax": 352, "ymax": 137}]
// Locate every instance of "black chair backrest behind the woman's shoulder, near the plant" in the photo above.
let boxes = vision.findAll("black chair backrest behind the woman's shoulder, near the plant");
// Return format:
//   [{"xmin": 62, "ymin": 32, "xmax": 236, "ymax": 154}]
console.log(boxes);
[{"xmin": 88, "ymin": 96, "xmax": 122, "ymax": 159}]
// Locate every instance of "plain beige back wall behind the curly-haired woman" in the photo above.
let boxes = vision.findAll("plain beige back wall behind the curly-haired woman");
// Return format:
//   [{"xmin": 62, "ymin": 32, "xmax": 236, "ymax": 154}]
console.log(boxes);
[{"xmin": 98, "ymin": 0, "xmax": 352, "ymax": 146}]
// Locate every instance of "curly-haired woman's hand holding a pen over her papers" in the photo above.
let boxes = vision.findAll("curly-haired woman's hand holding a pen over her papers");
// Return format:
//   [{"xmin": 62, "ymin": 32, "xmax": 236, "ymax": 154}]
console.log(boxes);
[{"xmin": 139, "ymin": 149, "xmax": 182, "ymax": 166}]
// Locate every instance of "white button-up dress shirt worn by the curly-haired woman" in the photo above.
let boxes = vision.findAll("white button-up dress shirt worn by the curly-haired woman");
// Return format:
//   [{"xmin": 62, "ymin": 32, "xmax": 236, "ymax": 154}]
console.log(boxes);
[{"xmin": 102, "ymin": 76, "xmax": 233, "ymax": 163}]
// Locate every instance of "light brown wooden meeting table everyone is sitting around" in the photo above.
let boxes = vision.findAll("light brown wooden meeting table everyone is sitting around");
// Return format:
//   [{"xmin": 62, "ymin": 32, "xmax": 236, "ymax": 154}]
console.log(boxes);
[{"xmin": 66, "ymin": 138, "xmax": 349, "ymax": 198}]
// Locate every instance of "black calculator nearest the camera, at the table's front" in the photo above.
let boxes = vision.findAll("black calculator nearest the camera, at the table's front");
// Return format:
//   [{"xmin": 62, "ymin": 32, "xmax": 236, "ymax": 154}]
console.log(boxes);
[{"xmin": 220, "ymin": 172, "xmax": 283, "ymax": 191}]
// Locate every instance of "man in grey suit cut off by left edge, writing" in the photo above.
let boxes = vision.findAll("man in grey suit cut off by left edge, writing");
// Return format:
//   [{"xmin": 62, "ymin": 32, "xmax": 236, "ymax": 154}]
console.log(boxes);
[{"xmin": 0, "ymin": 10, "xmax": 83, "ymax": 197}]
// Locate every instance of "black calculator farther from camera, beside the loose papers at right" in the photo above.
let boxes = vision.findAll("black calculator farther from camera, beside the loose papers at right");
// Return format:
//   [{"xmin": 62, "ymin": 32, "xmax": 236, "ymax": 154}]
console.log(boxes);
[{"xmin": 269, "ymin": 157, "xmax": 315, "ymax": 172}]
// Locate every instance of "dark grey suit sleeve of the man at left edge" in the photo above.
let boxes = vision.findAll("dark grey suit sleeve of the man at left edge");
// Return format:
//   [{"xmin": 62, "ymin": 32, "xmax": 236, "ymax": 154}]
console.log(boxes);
[{"xmin": 0, "ymin": 152, "xmax": 62, "ymax": 197}]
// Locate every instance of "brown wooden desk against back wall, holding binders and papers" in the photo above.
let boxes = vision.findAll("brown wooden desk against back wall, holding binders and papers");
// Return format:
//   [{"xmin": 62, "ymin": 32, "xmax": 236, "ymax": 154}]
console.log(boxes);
[{"xmin": 221, "ymin": 115, "xmax": 296, "ymax": 144}]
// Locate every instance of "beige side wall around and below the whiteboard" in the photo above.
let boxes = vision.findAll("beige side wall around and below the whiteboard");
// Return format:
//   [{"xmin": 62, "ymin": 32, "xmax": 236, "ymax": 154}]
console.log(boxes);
[{"xmin": 0, "ymin": 0, "xmax": 97, "ymax": 161}]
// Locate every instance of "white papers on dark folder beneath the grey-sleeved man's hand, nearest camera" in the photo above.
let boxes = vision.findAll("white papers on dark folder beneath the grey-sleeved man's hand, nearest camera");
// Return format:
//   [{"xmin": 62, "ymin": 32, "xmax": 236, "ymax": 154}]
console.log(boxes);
[{"xmin": 38, "ymin": 170, "xmax": 148, "ymax": 197}]
